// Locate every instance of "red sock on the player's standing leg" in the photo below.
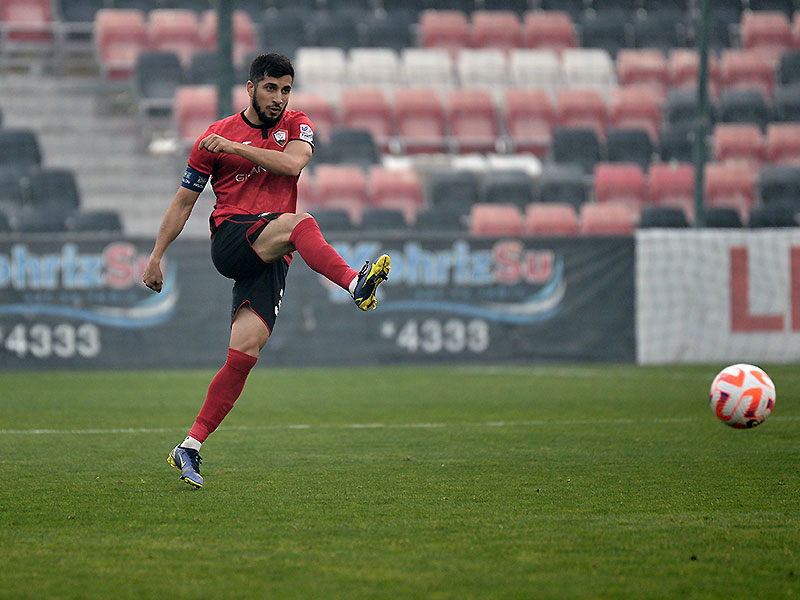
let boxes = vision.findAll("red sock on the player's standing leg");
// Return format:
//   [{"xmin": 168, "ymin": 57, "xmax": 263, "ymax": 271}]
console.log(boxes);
[{"xmin": 189, "ymin": 348, "xmax": 258, "ymax": 443}]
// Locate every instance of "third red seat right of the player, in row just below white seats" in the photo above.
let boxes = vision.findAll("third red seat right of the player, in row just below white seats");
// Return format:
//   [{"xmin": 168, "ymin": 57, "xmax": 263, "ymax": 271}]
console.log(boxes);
[{"xmin": 394, "ymin": 88, "xmax": 447, "ymax": 154}]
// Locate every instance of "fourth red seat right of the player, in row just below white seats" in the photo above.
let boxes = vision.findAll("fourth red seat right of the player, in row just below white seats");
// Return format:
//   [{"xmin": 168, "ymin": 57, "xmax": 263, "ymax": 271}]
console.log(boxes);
[{"xmin": 447, "ymin": 88, "xmax": 500, "ymax": 154}]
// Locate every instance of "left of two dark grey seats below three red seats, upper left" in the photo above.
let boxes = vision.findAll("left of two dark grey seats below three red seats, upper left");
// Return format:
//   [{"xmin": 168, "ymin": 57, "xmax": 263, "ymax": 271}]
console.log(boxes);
[{"xmin": 134, "ymin": 50, "xmax": 183, "ymax": 115}]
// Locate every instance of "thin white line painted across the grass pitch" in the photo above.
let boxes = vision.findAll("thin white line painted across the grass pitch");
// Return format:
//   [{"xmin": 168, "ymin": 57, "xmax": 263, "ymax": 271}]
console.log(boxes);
[{"xmin": 0, "ymin": 416, "xmax": 800, "ymax": 436}]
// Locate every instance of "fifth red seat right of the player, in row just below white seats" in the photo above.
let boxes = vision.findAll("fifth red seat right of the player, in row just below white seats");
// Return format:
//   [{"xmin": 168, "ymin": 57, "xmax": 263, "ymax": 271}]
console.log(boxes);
[{"xmin": 505, "ymin": 88, "xmax": 557, "ymax": 157}]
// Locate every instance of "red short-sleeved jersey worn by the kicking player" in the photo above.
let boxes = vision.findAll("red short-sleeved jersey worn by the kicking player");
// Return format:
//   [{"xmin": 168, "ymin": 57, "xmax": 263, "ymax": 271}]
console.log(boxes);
[{"xmin": 183, "ymin": 109, "xmax": 314, "ymax": 226}]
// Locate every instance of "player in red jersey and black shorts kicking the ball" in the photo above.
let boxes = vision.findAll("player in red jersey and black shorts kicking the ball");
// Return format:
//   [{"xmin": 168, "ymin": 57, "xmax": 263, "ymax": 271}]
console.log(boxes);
[{"xmin": 142, "ymin": 53, "xmax": 390, "ymax": 488}]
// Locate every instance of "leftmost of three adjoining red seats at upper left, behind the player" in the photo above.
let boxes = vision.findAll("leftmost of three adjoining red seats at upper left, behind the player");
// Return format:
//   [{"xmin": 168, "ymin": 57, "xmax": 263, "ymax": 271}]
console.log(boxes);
[{"xmin": 94, "ymin": 8, "xmax": 147, "ymax": 79}]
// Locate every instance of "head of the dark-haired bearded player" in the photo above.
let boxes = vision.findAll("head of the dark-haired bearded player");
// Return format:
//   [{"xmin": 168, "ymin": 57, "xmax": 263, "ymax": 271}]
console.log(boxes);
[{"xmin": 247, "ymin": 52, "xmax": 294, "ymax": 127}]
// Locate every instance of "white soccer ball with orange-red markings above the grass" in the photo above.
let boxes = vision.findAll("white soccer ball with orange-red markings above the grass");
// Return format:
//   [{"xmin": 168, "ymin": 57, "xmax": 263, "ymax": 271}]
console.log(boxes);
[{"xmin": 710, "ymin": 364, "xmax": 775, "ymax": 429}]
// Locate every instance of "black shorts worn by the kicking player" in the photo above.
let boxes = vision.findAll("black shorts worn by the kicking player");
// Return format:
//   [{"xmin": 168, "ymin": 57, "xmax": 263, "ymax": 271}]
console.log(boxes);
[{"xmin": 211, "ymin": 213, "xmax": 289, "ymax": 333}]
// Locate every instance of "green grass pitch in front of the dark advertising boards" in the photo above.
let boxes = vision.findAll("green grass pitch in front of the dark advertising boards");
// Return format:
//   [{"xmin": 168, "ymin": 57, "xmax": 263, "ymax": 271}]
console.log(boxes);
[{"xmin": 0, "ymin": 366, "xmax": 800, "ymax": 600}]
